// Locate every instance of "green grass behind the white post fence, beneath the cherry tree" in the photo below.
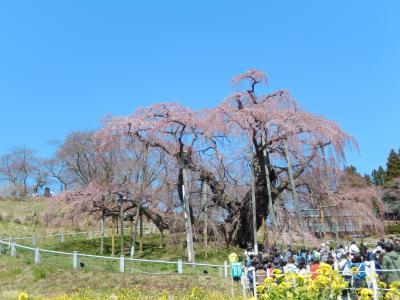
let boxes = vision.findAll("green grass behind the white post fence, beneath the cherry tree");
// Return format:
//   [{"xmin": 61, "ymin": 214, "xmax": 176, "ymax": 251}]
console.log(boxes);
[{"xmin": 6, "ymin": 235, "xmax": 240, "ymax": 276}]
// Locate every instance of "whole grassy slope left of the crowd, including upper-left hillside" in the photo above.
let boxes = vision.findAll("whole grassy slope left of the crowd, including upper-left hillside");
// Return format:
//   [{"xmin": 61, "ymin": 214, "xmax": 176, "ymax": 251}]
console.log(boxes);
[{"xmin": 0, "ymin": 200, "xmax": 244, "ymax": 299}]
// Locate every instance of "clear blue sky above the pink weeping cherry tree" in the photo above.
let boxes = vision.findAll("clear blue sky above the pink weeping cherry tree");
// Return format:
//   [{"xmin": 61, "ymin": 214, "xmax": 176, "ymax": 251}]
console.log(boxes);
[{"xmin": 0, "ymin": 0, "xmax": 400, "ymax": 176}]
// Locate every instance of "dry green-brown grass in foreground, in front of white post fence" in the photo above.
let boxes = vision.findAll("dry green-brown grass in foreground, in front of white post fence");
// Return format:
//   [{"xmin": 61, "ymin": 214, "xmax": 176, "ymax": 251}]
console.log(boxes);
[{"xmin": 0, "ymin": 255, "xmax": 241, "ymax": 299}]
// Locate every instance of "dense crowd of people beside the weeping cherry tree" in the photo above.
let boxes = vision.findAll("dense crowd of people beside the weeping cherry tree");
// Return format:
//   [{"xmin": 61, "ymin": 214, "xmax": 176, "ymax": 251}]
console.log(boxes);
[{"xmin": 229, "ymin": 238, "xmax": 400, "ymax": 299}]
